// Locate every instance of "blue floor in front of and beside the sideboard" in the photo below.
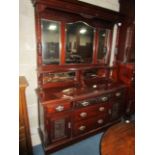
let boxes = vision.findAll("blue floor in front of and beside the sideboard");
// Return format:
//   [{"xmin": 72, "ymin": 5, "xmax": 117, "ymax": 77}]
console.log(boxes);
[{"xmin": 33, "ymin": 133, "xmax": 103, "ymax": 155}]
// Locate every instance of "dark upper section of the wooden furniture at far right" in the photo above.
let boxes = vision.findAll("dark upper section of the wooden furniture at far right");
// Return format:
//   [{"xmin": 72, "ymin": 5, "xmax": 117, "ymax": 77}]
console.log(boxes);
[{"xmin": 117, "ymin": 0, "xmax": 135, "ymax": 63}]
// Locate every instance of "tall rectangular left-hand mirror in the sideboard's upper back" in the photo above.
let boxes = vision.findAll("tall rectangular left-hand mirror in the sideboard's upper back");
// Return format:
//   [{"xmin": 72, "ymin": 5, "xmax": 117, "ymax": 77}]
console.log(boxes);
[{"xmin": 41, "ymin": 19, "xmax": 60, "ymax": 64}]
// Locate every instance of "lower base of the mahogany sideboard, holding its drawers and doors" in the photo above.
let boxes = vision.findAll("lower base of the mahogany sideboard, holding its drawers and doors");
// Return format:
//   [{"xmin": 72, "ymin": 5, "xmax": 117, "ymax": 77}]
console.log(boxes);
[{"xmin": 39, "ymin": 83, "xmax": 126, "ymax": 152}]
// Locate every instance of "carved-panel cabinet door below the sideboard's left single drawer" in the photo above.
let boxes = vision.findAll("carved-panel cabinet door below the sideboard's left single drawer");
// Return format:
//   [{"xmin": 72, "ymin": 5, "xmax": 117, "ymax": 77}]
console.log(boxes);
[{"xmin": 49, "ymin": 116, "xmax": 71, "ymax": 142}]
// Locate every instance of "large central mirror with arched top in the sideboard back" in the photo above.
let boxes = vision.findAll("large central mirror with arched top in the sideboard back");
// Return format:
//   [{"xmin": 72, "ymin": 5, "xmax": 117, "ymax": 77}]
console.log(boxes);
[{"xmin": 66, "ymin": 22, "xmax": 94, "ymax": 63}]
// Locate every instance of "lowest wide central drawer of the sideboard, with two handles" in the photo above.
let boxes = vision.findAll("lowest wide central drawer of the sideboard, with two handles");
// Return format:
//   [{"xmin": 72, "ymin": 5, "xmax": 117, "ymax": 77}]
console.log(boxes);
[{"xmin": 73, "ymin": 116, "xmax": 107, "ymax": 135}]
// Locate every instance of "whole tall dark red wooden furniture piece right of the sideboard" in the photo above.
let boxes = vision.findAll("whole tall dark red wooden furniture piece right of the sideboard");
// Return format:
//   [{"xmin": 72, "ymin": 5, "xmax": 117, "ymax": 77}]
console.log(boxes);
[{"xmin": 113, "ymin": 0, "xmax": 135, "ymax": 115}]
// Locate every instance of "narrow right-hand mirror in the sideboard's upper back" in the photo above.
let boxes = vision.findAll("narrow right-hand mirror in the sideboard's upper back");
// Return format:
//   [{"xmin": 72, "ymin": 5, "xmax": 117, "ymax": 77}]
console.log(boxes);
[{"xmin": 97, "ymin": 29, "xmax": 111, "ymax": 64}]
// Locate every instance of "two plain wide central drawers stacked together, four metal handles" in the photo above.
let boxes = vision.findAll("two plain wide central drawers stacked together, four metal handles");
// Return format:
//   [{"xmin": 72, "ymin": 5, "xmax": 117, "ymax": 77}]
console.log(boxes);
[{"xmin": 73, "ymin": 102, "xmax": 109, "ymax": 135}]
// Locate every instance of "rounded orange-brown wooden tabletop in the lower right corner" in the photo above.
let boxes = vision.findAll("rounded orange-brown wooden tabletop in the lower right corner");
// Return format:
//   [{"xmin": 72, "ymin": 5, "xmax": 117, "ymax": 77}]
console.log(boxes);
[{"xmin": 100, "ymin": 122, "xmax": 135, "ymax": 155}]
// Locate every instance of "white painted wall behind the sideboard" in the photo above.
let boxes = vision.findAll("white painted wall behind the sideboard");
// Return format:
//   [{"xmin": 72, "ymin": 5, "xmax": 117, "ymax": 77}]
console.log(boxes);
[{"xmin": 19, "ymin": 0, "xmax": 119, "ymax": 146}]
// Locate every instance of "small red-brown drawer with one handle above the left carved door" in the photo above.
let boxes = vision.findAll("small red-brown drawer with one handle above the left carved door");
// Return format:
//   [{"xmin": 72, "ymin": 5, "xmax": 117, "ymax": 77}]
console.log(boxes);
[{"xmin": 46, "ymin": 102, "xmax": 72, "ymax": 114}]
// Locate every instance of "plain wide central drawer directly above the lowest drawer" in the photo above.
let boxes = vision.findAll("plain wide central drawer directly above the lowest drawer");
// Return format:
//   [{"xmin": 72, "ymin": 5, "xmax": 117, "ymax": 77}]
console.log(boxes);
[{"xmin": 73, "ymin": 103, "xmax": 108, "ymax": 121}]
